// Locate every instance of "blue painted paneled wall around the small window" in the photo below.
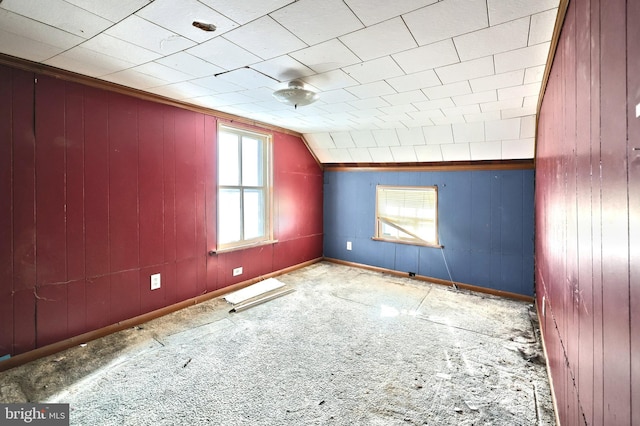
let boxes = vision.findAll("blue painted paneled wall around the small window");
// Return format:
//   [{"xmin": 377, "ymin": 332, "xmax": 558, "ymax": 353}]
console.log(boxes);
[{"xmin": 324, "ymin": 170, "xmax": 534, "ymax": 296}]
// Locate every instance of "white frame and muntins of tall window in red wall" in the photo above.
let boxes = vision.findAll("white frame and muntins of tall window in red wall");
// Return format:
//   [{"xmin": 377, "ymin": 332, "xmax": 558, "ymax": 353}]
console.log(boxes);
[{"xmin": 216, "ymin": 123, "xmax": 275, "ymax": 253}]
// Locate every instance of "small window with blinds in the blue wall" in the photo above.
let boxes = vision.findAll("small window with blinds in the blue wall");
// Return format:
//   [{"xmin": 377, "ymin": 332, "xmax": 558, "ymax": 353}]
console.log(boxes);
[{"xmin": 374, "ymin": 185, "xmax": 439, "ymax": 246}]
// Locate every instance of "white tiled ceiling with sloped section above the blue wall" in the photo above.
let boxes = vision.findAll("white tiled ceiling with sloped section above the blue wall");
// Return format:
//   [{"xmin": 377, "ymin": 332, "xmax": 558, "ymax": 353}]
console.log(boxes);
[{"xmin": 0, "ymin": 0, "xmax": 559, "ymax": 163}]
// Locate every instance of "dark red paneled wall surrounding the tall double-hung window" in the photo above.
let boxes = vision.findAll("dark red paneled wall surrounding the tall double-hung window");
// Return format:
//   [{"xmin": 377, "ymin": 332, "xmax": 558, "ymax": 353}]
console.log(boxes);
[{"xmin": 0, "ymin": 66, "xmax": 323, "ymax": 356}]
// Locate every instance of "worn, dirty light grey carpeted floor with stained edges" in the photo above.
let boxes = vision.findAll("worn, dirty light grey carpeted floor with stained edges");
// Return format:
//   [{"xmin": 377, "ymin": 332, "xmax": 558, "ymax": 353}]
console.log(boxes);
[{"xmin": 0, "ymin": 262, "xmax": 554, "ymax": 425}]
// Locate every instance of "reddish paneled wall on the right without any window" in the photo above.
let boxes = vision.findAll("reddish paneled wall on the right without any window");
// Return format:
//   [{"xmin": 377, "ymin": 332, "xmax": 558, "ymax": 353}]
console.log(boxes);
[{"xmin": 536, "ymin": 0, "xmax": 640, "ymax": 425}]
